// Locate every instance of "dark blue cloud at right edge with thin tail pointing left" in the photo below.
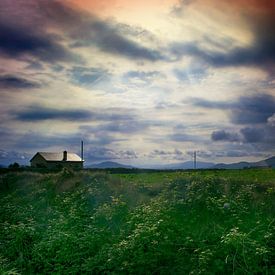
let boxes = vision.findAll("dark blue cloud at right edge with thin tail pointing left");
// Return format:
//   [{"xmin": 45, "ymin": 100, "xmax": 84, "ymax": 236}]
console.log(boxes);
[{"xmin": 190, "ymin": 94, "xmax": 275, "ymax": 124}]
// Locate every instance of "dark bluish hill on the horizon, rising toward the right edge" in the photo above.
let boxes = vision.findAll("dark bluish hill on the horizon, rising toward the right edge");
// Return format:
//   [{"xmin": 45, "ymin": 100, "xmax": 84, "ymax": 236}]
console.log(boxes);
[{"xmin": 211, "ymin": 156, "xmax": 275, "ymax": 169}]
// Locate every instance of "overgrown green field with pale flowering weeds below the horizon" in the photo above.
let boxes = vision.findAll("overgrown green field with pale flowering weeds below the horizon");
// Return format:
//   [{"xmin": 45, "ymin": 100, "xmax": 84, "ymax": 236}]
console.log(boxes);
[{"xmin": 0, "ymin": 169, "xmax": 275, "ymax": 274}]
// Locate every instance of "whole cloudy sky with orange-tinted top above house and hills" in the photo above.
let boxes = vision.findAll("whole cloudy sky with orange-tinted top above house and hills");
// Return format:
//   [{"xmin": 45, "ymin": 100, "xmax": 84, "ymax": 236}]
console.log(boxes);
[{"xmin": 0, "ymin": 0, "xmax": 275, "ymax": 167}]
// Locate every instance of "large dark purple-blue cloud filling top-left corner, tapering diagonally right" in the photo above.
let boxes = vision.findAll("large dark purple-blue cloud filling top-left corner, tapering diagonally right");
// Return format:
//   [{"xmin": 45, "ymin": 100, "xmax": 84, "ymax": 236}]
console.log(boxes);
[{"xmin": 0, "ymin": 0, "xmax": 163, "ymax": 62}]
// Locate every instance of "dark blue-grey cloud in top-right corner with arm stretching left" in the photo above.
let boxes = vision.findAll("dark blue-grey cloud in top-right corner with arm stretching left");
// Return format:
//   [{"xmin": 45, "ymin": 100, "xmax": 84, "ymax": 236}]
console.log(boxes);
[{"xmin": 171, "ymin": 10, "xmax": 275, "ymax": 72}]
